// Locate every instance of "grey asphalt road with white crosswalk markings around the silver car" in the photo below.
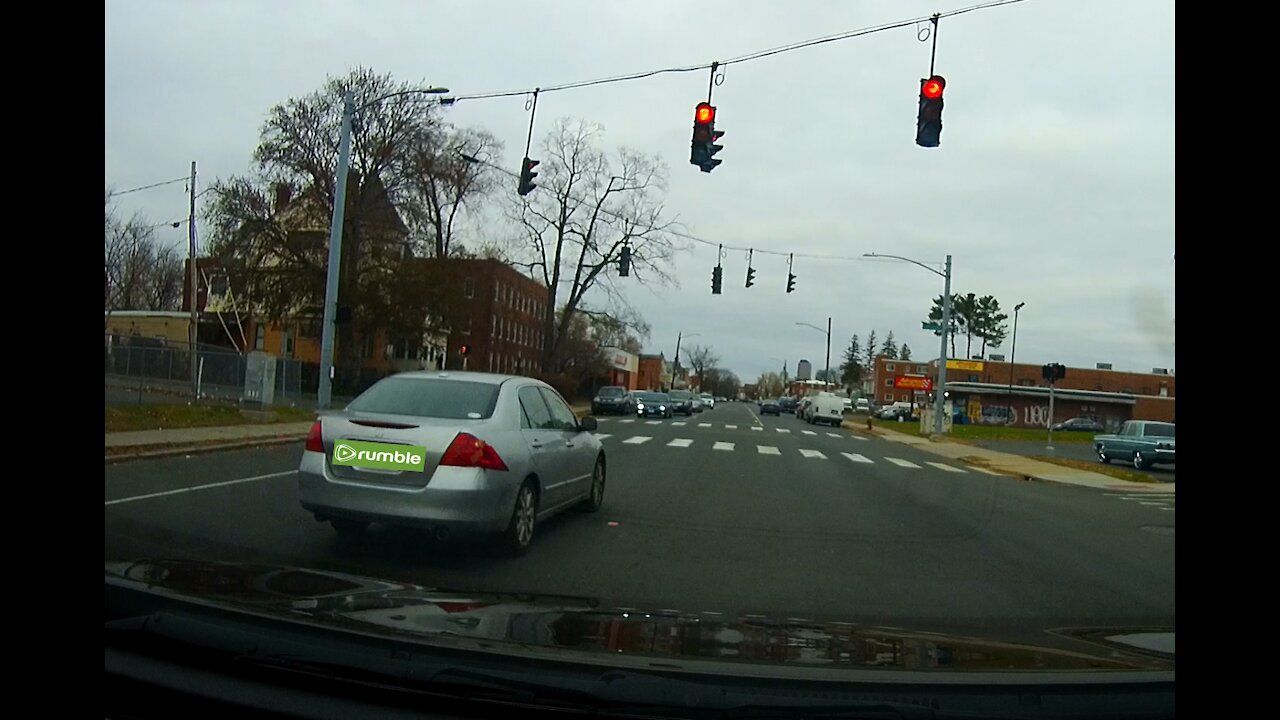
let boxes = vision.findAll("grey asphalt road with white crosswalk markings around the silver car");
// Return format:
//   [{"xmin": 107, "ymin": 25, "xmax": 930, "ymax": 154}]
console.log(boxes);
[{"xmin": 105, "ymin": 402, "xmax": 1175, "ymax": 630}]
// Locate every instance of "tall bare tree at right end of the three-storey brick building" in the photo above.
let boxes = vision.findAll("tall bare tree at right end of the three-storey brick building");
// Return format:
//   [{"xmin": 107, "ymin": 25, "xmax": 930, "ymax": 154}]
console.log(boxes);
[{"xmin": 511, "ymin": 119, "xmax": 680, "ymax": 372}]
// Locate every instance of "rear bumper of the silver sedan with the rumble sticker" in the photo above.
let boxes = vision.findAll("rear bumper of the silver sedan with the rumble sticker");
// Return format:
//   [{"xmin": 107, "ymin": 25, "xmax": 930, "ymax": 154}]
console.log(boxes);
[{"xmin": 298, "ymin": 452, "xmax": 520, "ymax": 534}]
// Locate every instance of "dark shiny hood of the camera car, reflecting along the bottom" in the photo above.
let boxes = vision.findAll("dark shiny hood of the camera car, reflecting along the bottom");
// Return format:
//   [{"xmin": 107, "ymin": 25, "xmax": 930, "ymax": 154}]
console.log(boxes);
[{"xmin": 106, "ymin": 560, "xmax": 1174, "ymax": 674}]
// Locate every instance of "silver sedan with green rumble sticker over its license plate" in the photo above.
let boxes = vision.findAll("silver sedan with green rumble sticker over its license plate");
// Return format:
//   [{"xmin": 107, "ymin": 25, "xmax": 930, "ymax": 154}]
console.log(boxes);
[{"xmin": 298, "ymin": 370, "xmax": 605, "ymax": 555}]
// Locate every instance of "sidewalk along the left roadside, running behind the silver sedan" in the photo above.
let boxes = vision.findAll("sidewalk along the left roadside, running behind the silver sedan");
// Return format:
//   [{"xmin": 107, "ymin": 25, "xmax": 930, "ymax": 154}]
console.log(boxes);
[{"xmin": 105, "ymin": 404, "xmax": 591, "ymax": 462}]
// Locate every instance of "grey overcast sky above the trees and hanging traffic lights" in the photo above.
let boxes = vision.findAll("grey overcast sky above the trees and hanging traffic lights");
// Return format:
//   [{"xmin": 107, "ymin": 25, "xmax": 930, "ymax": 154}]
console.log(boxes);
[{"xmin": 105, "ymin": 0, "xmax": 1174, "ymax": 382}]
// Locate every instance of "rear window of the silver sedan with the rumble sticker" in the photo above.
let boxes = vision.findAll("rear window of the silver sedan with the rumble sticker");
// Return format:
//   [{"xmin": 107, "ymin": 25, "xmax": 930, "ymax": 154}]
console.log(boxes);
[{"xmin": 347, "ymin": 378, "xmax": 498, "ymax": 420}]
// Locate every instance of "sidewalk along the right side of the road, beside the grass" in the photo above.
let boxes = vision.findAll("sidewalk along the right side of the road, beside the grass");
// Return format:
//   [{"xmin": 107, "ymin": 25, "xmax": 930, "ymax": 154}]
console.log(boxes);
[{"xmin": 845, "ymin": 420, "xmax": 1175, "ymax": 493}]
